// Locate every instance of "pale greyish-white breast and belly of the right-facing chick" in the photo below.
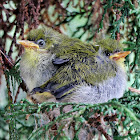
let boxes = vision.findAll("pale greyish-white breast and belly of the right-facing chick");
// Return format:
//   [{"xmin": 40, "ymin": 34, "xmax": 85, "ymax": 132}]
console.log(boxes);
[{"xmin": 60, "ymin": 66, "xmax": 126, "ymax": 104}]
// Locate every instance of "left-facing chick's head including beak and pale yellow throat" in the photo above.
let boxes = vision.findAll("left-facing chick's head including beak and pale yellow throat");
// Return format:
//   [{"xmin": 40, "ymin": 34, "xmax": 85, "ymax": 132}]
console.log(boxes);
[{"xmin": 19, "ymin": 27, "xmax": 63, "ymax": 66}]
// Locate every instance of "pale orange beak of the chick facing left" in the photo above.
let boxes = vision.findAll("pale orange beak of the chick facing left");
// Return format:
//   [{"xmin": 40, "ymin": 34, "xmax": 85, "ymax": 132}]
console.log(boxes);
[{"xmin": 18, "ymin": 40, "xmax": 39, "ymax": 49}]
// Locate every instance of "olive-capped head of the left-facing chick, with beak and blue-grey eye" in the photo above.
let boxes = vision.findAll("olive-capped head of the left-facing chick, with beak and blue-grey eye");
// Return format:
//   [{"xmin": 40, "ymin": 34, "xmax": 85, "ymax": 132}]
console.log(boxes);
[{"xmin": 19, "ymin": 27, "xmax": 62, "ymax": 52}]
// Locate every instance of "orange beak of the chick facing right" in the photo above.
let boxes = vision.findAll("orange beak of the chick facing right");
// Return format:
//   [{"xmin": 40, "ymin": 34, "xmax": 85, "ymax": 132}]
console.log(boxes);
[{"xmin": 109, "ymin": 51, "xmax": 131, "ymax": 61}]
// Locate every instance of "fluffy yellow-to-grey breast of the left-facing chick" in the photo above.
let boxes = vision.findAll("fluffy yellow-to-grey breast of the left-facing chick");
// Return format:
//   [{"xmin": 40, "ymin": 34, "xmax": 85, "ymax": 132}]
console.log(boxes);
[{"xmin": 20, "ymin": 54, "xmax": 57, "ymax": 91}]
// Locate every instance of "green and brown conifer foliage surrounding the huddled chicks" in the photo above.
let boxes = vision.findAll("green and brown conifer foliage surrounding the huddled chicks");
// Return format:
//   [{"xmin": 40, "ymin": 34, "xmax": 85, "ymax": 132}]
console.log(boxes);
[{"xmin": 0, "ymin": 0, "xmax": 140, "ymax": 140}]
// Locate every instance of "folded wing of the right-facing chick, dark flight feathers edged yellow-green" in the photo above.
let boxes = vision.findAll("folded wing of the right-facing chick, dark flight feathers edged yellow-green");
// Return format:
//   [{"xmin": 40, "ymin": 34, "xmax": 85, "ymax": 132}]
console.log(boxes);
[{"xmin": 32, "ymin": 61, "xmax": 84, "ymax": 99}]
